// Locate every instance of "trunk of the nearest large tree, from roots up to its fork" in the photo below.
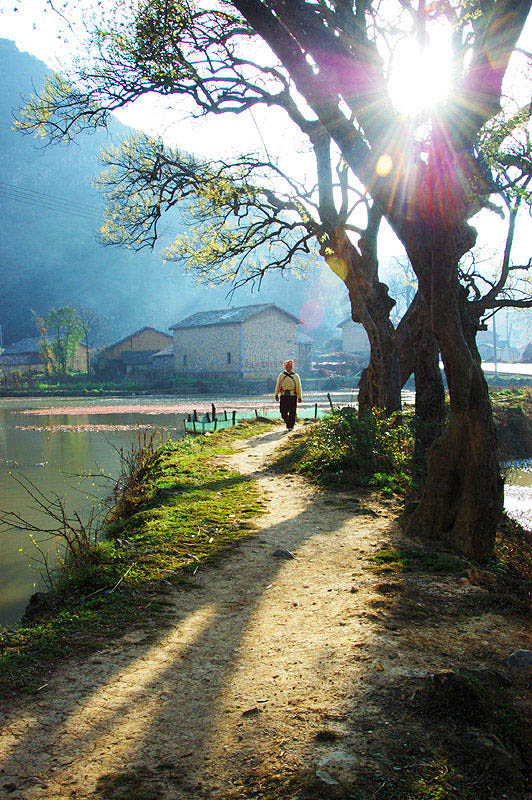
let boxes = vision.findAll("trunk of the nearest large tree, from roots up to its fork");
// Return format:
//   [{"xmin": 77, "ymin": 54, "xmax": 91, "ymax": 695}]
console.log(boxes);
[{"xmin": 399, "ymin": 123, "xmax": 504, "ymax": 558}]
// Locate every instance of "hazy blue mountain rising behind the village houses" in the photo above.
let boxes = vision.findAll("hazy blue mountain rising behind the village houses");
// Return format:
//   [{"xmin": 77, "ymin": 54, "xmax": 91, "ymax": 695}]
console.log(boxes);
[{"xmin": 0, "ymin": 39, "xmax": 345, "ymax": 343}]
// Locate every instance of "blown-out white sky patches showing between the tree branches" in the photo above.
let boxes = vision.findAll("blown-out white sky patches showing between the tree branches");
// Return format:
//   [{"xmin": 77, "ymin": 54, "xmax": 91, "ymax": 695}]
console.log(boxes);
[{"xmin": 0, "ymin": 0, "xmax": 532, "ymax": 272}]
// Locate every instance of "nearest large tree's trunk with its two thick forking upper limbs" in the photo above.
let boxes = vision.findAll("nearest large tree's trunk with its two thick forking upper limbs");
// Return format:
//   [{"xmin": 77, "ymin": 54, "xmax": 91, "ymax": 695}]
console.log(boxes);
[{"xmin": 238, "ymin": 0, "xmax": 531, "ymax": 556}]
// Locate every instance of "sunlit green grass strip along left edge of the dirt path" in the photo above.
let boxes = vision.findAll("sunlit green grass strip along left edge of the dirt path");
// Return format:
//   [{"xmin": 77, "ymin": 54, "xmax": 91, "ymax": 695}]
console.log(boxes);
[{"xmin": 0, "ymin": 423, "xmax": 270, "ymax": 691}]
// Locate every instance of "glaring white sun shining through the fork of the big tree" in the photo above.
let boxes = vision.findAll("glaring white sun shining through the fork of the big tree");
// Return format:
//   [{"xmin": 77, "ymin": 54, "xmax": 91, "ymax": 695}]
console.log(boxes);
[{"xmin": 388, "ymin": 35, "xmax": 451, "ymax": 117}]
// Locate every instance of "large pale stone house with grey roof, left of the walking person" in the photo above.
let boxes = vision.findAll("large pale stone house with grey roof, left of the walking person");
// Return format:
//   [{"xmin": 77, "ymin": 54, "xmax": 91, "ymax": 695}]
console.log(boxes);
[{"xmin": 170, "ymin": 303, "xmax": 302, "ymax": 381}]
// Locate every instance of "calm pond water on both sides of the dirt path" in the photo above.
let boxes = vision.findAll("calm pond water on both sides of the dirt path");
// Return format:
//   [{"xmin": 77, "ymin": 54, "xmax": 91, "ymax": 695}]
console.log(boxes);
[{"xmin": 0, "ymin": 392, "xmax": 532, "ymax": 625}]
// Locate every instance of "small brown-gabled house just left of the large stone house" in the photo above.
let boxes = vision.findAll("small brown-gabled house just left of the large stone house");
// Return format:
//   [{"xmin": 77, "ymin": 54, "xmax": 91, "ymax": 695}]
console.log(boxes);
[{"xmin": 96, "ymin": 326, "xmax": 172, "ymax": 378}]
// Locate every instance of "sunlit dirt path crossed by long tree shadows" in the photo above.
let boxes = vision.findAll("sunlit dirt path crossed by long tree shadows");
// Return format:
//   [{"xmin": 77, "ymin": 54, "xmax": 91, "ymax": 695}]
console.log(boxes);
[{"xmin": 0, "ymin": 430, "xmax": 527, "ymax": 800}]
